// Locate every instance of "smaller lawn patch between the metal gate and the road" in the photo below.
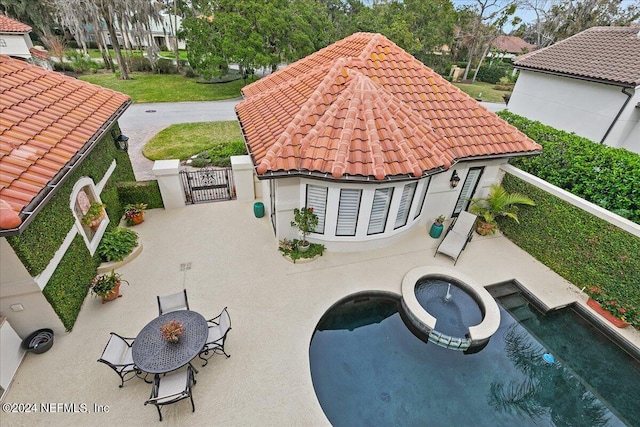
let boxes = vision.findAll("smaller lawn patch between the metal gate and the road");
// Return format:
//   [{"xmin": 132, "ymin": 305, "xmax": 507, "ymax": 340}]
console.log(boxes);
[{"xmin": 142, "ymin": 121, "xmax": 243, "ymax": 160}]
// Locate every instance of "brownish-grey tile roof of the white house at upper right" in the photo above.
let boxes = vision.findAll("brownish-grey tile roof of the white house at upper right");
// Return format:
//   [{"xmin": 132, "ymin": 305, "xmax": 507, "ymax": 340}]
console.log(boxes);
[{"xmin": 514, "ymin": 27, "xmax": 640, "ymax": 87}]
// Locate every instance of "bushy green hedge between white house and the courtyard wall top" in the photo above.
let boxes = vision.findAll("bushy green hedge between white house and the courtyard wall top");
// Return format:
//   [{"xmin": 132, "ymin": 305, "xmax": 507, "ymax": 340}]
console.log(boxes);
[{"xmin": 498, "ymin": 111, "xmax": 640, "ymax": 224}]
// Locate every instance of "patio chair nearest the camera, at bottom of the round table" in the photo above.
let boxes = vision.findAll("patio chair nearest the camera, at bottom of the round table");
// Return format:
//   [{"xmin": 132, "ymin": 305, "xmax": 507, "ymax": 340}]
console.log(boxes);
[{"xmin": 144, "ymin": 365, "xmax": 196, "ymax": 421}]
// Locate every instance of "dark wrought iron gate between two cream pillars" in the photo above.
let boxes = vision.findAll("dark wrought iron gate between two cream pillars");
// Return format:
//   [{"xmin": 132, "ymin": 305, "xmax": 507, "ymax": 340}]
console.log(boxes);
[{"xmin": 180, "ymin": 167, "xmax": 236, "ymax": 204}]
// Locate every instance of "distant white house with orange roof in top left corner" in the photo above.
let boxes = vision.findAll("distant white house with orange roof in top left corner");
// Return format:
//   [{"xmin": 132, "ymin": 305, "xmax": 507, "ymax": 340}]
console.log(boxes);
[{"xmin": 0, "ymin": 14, "xmax": 53, "ymax": 70}]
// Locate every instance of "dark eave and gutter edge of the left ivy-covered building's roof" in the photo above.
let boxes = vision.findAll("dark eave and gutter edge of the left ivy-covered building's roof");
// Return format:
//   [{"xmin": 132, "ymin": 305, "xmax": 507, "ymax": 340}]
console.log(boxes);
[{"xmin": 0, "ymin": 99, "xmax": 132, "ymax": 237}]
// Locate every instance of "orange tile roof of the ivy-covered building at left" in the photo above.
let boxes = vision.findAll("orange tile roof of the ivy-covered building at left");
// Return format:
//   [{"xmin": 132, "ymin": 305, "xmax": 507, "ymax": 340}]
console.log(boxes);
[{"xmin": 0, "ymin": 55, "xmax": 131, "ymax": 232}]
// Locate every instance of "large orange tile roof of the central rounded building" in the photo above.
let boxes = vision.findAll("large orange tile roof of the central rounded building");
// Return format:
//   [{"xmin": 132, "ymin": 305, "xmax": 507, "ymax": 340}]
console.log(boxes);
[{"xmin": 236, "ymin": 33, "xmax": 541, "ymax": 180}]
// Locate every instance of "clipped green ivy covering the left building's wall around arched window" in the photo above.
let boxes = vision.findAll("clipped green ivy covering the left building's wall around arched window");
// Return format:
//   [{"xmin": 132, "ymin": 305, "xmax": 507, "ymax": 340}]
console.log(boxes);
[{"xmin": 7, "ymin": 125, "xmax": 135, "ymax": 330}]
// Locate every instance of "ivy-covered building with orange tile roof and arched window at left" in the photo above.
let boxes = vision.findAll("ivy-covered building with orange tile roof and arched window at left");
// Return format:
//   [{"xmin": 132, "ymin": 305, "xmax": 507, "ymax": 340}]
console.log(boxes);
[{"xmin": 0, "ymin": 55, "xmax": 133, "ymax": 351}]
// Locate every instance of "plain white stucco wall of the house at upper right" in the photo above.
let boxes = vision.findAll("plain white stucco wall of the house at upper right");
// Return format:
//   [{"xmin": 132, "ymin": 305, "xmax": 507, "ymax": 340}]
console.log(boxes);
[{"xmin": 508, "ymin": 70, "xmax": 640, "ymax": 152}]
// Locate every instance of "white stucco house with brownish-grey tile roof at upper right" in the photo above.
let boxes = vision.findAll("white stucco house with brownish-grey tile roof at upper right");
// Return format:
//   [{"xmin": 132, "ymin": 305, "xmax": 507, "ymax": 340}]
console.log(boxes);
[{"xmin": 509, "ymin": 27, "xmax": 640, "ymax": 153}]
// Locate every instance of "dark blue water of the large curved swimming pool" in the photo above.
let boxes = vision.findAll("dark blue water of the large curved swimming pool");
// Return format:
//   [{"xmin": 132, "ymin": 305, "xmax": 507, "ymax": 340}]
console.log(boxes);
[{"xmin": 309, "ymin": 294, "xmax": 640, "ymax": 427}]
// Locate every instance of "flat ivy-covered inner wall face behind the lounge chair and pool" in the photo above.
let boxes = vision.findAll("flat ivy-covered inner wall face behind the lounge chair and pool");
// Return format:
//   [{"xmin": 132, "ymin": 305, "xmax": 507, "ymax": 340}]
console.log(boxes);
[{"xmin": 498, "ymin": 175, "xmax": 640, "ymax": 327}]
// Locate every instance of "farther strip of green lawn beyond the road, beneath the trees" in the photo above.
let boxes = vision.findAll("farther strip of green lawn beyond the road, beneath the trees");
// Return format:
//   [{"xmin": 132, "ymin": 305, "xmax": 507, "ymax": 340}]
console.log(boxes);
[{"xmin": 78, "ymin": 73, "xmax": 252, "ymax": 103}]
